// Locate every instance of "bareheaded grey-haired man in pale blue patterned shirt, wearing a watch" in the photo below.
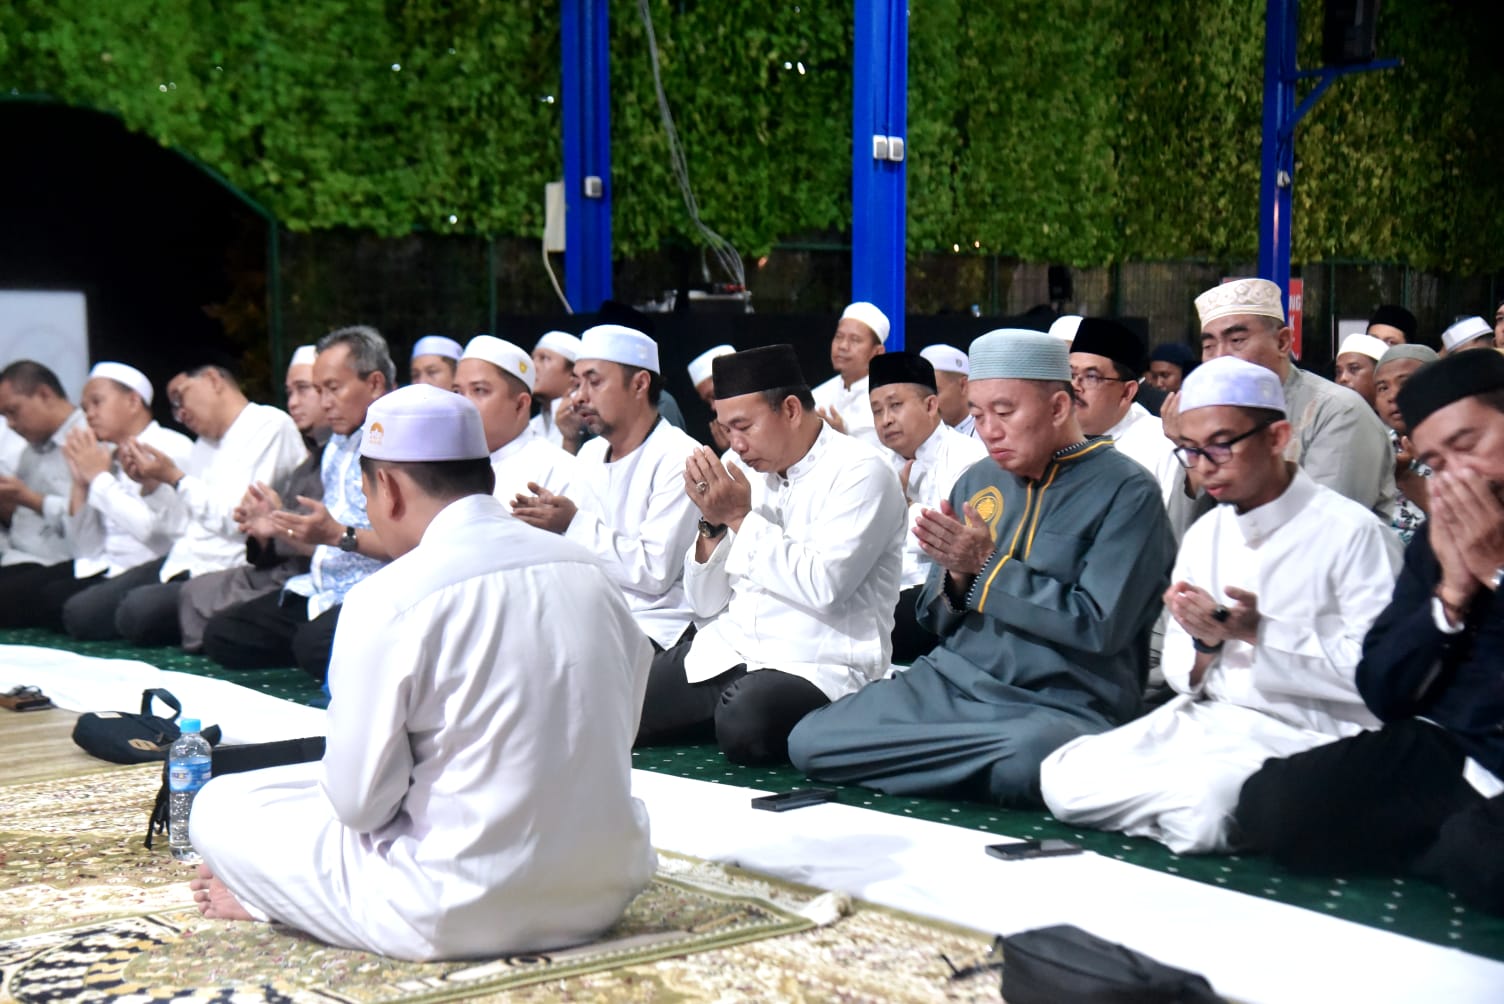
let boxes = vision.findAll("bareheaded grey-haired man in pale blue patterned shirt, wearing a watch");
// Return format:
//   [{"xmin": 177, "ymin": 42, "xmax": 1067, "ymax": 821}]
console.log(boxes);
[{"xmin": 203, "ymin": 325, "xmax": 400, "ymax": 682}]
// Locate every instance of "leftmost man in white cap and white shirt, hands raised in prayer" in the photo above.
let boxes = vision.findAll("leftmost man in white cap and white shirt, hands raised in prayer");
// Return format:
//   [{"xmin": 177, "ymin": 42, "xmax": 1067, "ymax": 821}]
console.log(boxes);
[{"xmin": 0, "ymin": 362, "xmax": 193, "ymax": 631}]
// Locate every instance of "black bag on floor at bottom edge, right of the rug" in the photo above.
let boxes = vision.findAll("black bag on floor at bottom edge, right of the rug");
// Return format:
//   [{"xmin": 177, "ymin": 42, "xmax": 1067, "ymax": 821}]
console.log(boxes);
[{"xmin": 1002, "ymin": 924, "xmax": 1223, "ymax": 1004}]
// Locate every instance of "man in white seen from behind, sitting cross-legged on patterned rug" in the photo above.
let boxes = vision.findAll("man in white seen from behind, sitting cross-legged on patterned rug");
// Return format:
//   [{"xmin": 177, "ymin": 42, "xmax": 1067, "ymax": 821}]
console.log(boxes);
[{"xmin": 191, "ymin": 386, "xmax": 654, "ymax": 960}]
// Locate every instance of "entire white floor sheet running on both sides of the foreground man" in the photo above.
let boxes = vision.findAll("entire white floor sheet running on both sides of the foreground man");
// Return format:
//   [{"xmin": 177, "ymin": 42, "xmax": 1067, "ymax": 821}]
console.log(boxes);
[{"xmin": 0, "ymin": 646, "xmax": 1504, "ymax": 1004}]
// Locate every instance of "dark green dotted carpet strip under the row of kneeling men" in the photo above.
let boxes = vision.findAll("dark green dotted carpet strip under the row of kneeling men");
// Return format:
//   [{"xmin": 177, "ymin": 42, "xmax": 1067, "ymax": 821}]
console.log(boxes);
[{"xmin": 11, "ymin": 628, "xmax": 1504, "ymax": 962}]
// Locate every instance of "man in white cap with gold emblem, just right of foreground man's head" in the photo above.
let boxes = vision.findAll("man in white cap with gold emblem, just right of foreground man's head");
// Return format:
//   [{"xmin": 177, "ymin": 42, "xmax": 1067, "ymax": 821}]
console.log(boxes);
[{"xmin": 454, "ymin": 335, "xmax": 600, "ymax": 508}]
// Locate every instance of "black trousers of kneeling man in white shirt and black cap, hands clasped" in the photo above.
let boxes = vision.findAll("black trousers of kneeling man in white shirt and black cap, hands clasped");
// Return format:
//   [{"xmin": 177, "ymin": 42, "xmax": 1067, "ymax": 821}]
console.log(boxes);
[{"xmin": 636, "ymin": 639, "xmax": 830, "ymax": 765}]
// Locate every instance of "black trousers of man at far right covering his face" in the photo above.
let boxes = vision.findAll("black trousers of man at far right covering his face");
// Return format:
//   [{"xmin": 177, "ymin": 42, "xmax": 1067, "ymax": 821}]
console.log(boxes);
[{"xmin": 1236, "ymin": 718, "xmax": 1504, "ymax": 912}]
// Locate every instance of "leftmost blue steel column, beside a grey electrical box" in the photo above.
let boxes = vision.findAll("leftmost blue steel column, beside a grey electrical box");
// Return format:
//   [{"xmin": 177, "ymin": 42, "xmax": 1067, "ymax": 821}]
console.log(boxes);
[{"xmin": 559, "ymin": 0, "xmax": 611, "ymax": 314}]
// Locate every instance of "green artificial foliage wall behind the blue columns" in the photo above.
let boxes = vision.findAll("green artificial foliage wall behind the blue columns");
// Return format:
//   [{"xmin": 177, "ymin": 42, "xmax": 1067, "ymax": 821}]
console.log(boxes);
[{"xmin": 0, "ymin": 0, "xmax": 1504, "ymax": 272}]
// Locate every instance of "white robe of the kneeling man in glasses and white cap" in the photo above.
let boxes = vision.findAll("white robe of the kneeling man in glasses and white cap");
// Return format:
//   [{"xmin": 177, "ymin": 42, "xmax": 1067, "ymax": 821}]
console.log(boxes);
[{"xmin": 1039, "ymin": 469, "xmax": 1399, "ymax": 854}]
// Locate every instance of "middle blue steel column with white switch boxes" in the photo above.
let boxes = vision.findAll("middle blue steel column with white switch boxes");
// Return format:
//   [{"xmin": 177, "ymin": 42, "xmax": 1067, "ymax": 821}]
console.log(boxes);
[{"xmin": 851, "ymin": 0, "xmax": 908, "ymax": 350}]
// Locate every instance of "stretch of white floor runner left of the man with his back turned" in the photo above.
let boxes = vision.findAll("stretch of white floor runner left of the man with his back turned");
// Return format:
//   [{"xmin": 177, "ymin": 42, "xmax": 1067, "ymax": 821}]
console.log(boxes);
[{"xmin": 0, "ymin": 645, "xmax": 323, "ymax": 744}]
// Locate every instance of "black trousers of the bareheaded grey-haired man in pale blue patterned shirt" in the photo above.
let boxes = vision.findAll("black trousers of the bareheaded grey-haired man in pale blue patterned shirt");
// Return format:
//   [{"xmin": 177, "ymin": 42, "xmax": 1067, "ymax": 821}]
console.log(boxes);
[{"xmin": 203, "ymin": 589, "xmax": 340, "ymax": 682}]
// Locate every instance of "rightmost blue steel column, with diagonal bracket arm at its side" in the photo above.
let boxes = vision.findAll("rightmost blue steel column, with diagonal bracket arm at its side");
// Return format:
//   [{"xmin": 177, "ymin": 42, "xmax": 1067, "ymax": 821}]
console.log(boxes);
[{"xmin": 1259, "ymin": 0, "xmax": 1299, "ymax": 314}]
